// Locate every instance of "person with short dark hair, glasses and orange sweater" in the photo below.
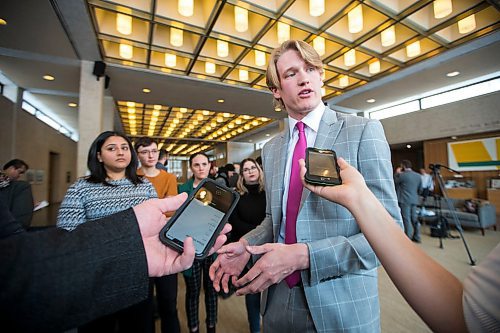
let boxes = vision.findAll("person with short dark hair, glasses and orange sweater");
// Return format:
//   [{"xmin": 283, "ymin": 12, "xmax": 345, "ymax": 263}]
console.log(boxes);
[{"xmin": 134, "ymin": 137, "xmax": 180, "ymax": 333}]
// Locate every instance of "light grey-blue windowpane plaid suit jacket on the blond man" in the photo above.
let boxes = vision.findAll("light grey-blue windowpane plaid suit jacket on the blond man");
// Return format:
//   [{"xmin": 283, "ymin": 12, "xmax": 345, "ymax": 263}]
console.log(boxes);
[{"xmin": 244, "ymin": 107, "xmax": 402, "ymax": 332}]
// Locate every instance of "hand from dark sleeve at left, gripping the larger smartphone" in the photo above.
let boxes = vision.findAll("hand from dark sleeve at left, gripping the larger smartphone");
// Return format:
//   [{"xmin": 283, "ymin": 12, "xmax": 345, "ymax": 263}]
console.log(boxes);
[{"xmin": 133, "ymin": 193, "xmax": 231, "ymax": 277}]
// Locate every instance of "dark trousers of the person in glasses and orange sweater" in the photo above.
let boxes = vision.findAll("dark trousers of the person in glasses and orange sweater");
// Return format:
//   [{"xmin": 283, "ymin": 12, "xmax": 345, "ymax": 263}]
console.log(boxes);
[{"xmin": 154, "ymin": 274, "xmax": 181, "ymax": 333}]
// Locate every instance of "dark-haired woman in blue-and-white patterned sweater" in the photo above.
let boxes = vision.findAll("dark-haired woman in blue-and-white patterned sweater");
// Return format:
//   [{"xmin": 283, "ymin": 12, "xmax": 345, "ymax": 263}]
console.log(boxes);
[{"xmin": 57, "ymin": 131, "xmax": 157, "ymax": 230}]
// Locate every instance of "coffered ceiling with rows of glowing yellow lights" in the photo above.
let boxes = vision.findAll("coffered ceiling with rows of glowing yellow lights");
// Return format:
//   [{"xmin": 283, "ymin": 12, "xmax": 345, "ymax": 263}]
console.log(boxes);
[{"xmin": 0, "ymin": 0, "xmax": 500, "ymax": 155}]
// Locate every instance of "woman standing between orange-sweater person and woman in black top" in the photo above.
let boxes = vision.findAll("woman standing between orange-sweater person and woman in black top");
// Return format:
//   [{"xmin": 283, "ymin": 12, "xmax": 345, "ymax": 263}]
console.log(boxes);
[{"xmin": 179, "ymin": 153, "xmax": 217, "ymax": 333}]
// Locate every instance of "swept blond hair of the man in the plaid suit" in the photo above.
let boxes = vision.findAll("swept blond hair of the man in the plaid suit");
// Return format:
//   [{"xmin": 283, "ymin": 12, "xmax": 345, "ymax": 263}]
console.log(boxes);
[{"xmin": 266, "ymin": 40, "xmax": 323, "ymax": 108}]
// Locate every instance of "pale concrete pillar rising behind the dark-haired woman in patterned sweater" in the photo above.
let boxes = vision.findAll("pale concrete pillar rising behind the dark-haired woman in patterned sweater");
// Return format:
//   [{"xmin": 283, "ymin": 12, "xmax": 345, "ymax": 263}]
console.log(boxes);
[{"xmin": 76, "ymin": 60, "xmax": 104, "ymax": 177}]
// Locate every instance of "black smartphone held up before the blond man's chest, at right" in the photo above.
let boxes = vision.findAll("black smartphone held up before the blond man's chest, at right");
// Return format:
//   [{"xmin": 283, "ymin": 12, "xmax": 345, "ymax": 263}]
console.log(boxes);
[{"xmin": 304, "ymin": 147, "xmax": 342, "ymax": 186}]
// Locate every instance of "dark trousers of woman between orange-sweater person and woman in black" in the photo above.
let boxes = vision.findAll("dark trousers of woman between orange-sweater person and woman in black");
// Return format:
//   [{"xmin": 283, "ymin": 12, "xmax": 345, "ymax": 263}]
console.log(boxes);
[{"xmin": 184, "ymin": 255, "xmax": 217, "ymax": 330}]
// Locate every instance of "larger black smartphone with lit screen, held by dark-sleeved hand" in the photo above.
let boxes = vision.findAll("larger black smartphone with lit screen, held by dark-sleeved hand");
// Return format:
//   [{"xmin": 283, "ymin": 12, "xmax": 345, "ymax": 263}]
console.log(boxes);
[{"xmin": 160, "ymin": 178, "xmax": 240, "ymax": 259}]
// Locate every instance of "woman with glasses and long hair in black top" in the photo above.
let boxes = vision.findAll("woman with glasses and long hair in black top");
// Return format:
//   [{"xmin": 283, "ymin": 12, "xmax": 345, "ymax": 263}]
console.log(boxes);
[{"xmin": 229, "ymin": 158, "xmax": 266, "ymax": 333}]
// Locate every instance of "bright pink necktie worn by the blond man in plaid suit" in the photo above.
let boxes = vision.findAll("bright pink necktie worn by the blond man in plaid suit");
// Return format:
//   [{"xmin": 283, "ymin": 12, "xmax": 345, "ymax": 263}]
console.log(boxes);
[{"xmin": 285, "ymin": 121, "xmax": 307, "ymax": 288}]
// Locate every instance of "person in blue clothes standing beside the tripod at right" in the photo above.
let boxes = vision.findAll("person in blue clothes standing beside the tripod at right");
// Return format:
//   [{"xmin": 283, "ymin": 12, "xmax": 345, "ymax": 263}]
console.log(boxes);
[{"xmin": 394, "ymin": 160, "xmax": 422, "ymax": 243}]
